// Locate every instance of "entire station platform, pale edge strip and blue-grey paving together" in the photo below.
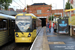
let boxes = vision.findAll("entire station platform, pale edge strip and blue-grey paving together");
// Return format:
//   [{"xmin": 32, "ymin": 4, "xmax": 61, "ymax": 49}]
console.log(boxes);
[{"xmin": 30, "ymin": 27, "xmax": 75, "ymax": 50}]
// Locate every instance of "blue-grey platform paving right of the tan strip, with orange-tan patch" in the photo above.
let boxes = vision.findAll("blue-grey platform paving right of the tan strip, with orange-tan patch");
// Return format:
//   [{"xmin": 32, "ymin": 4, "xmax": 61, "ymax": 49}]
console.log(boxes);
[{"xmin": 46, "ymin": 28, "xmax": 75, "ymax": 50}]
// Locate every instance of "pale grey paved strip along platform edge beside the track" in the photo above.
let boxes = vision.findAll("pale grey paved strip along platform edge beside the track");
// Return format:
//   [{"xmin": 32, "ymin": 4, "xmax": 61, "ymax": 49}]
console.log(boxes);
[{"xmin": 30, "ymin": 28, "xmax": 44, "ymax": 50}]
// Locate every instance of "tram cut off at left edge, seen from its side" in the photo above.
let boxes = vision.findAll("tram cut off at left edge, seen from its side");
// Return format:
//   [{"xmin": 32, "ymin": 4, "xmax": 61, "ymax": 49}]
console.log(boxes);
[{"xmin": 0, "ymin": 14, "xmax": 15, "ymax": 46}]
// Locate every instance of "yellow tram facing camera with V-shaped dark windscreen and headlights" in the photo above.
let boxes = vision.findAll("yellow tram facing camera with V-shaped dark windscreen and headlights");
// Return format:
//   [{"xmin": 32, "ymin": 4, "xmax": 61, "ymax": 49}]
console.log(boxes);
[{"xmin": 15, "ymin": 14, "xmax": 36, "ymax": 43}]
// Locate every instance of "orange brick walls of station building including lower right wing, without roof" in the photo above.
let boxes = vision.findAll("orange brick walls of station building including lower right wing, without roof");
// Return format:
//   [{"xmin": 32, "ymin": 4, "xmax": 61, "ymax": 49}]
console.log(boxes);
[{"xmin": 27, "ymin": 5, "xmax": 63, "ymax": 17}]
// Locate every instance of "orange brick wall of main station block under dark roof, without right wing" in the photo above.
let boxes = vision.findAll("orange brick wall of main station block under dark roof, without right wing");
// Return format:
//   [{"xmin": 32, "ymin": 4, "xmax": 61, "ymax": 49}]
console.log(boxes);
[{"xmin": 27, "ymin": 5, "xmax": 52, "ymax": 17}]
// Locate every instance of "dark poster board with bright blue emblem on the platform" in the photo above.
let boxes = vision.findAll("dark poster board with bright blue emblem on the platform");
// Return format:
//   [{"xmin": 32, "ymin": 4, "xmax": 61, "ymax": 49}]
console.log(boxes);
[{"xmin": 58, "ymin": 19, "xmax": 69, "ymax": 34}]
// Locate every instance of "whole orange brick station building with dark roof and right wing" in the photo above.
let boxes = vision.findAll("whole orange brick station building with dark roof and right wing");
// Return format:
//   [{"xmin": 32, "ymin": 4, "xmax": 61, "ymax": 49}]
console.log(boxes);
[{"xmin": 27, "ymin": 3, "xmax": 63, "ymax": 26}]
